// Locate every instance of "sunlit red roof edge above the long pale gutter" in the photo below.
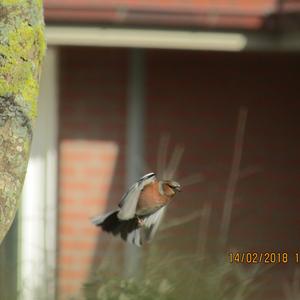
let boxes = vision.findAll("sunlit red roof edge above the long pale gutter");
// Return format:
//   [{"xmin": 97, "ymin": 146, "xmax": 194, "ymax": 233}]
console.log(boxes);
[{"xmin": 44, "ymin": 0, "xmax": 276, "ymax": 29}]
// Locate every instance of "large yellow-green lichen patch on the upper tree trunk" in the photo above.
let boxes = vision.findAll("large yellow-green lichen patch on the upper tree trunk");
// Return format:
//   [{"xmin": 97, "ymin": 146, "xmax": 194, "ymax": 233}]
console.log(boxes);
[{"xmin": 0, "ymin": 22, "xmax": 46, "ymax": 119}]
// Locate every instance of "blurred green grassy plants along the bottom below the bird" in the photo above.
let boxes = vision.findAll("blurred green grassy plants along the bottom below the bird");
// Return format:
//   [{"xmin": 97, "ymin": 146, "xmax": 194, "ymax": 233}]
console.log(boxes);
[{"xmin": 84, "ymin": 240, "xmax": 263, "ymax": 300}]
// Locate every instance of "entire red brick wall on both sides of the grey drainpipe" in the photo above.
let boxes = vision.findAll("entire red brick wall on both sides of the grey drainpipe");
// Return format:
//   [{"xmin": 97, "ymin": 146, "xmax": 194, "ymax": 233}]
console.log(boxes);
[{"xmin": 58, "ymin": 48, "xmax": 300, "ymax": 299}]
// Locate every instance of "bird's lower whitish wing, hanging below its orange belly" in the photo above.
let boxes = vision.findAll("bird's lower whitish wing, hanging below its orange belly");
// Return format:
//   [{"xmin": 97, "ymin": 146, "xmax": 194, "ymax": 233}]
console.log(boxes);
[{"xmin": 126, "ymin": 206, "xmax": 166, "ymax": 247}]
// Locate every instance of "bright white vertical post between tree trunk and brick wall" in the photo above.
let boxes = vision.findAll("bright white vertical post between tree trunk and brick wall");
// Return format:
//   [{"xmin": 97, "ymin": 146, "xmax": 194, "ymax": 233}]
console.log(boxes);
[{"xmin": 19, "ymin": 47, "xmax": 59, "ymax": 300}]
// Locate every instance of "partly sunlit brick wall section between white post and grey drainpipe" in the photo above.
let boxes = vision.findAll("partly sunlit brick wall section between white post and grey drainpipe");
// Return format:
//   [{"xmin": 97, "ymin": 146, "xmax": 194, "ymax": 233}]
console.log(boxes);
[{"xmin": 58, "ymin": 48, "xmax": 127, "ymax": 299}]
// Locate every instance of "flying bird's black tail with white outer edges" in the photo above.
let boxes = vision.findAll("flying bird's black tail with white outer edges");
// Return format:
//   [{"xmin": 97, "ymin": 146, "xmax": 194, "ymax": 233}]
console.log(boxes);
[{"xmin": 92, "ymin": 210, "xmax": 142, "ymax": 246}]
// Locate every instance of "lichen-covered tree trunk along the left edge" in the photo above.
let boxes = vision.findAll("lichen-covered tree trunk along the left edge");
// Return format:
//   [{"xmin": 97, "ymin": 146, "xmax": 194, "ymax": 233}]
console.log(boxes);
[{"xmin": 0, "ymin": 0, "xmax": 45, "ymax": 243}]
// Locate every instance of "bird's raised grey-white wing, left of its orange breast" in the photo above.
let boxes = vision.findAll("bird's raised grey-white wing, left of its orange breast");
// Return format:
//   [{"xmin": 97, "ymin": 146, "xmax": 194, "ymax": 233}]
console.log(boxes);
[{"xmin": 118, "ymin": 173, "xmax": 156, "ymax": 220}]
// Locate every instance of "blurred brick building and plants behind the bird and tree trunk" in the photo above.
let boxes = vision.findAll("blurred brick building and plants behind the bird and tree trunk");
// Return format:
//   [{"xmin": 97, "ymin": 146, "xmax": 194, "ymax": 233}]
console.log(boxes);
[{"xmin": 0, "ymin": 0, "xmax": 300, "ymax": 300}]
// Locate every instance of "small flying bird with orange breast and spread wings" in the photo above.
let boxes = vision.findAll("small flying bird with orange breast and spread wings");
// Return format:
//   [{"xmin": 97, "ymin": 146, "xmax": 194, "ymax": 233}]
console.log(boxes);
[{"xmin": 92, "ymin": 173, "xmax": 181, "ymax": 246}]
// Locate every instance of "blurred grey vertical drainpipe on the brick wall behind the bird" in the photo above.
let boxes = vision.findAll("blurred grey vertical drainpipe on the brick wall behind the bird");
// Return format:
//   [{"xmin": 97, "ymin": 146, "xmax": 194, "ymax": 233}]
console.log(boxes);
[{"xmin": 124, "ymin": 49, "xmax": 145, "ymax": 277}]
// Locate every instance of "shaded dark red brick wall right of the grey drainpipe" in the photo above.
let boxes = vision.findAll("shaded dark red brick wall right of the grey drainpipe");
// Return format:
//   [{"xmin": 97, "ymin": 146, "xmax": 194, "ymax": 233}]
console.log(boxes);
[{"xmin": 147, "ymin": 51, "xmax": 300, "ymax": 251}]
